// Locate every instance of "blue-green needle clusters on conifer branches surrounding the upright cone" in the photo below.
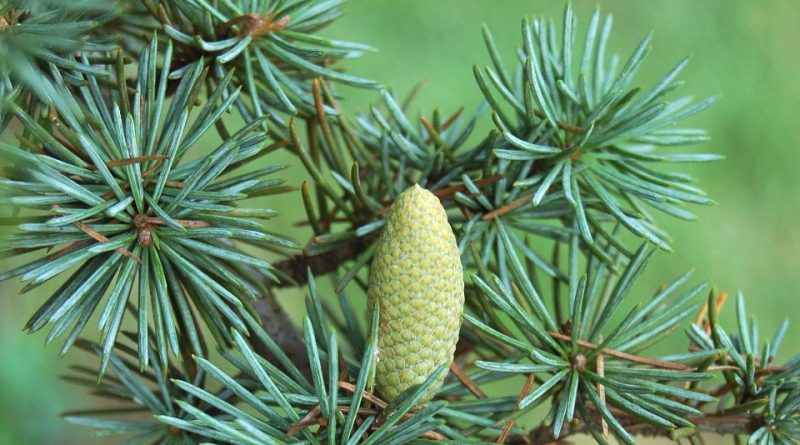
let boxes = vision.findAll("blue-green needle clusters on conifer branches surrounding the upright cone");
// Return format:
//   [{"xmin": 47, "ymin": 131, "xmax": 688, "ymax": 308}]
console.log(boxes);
[{"xmin": 0, "ymin": 0, "xmax": 800, "ymax": 445}]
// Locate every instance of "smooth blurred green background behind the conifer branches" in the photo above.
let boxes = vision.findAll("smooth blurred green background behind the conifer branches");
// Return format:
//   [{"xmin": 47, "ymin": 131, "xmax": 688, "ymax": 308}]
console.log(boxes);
[{"xmin": 0, "ymin": 0, "xmax": 800, "ymax": 445}]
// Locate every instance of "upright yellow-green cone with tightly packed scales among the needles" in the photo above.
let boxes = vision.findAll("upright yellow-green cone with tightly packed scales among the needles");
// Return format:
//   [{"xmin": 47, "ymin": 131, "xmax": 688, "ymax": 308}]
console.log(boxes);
[{"xmin": 367, "ymin": 185, "xmax": 464, "ymax": 402}]
